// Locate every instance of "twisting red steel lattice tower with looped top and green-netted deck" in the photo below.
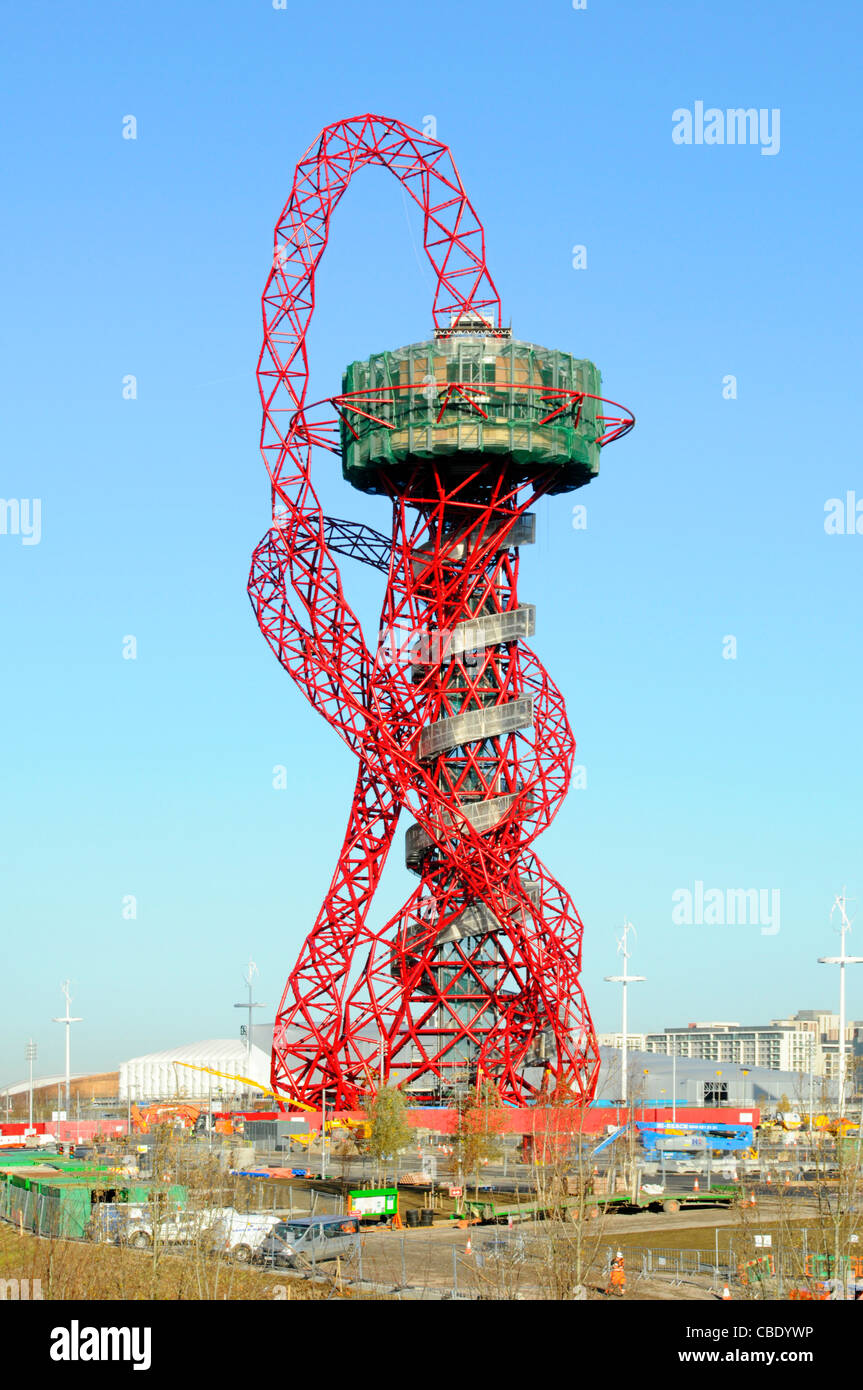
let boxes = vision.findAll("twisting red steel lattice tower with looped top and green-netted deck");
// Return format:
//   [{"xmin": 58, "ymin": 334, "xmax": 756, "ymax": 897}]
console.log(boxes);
[{"xmin": 249, "ymin": 115, "xmax": 634, "ymax": 1108}]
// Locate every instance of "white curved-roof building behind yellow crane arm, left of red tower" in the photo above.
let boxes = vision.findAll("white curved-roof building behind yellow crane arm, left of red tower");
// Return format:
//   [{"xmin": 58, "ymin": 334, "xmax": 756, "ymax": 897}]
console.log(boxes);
[{"xmin": 120, "ymin": 1038, "xmax": 270, "ymax": 1101}]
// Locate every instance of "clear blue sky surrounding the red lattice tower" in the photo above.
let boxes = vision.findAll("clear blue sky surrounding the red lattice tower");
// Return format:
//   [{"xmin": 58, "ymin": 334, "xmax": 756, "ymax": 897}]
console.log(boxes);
[{"xmin": 0, "ymin": 0, "xmax": 863, "ymax": 1080}]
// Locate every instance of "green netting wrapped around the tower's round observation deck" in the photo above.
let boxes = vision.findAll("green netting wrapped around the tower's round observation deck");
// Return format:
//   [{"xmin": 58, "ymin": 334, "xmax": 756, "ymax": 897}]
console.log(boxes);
[{"xmin": 336, "ymin": 338, "xmax": 603, "ymax": 492}]
